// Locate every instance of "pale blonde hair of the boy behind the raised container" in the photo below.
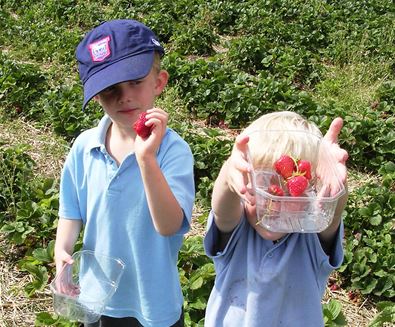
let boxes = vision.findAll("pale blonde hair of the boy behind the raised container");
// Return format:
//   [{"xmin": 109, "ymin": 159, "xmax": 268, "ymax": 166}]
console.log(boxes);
[{"xmin": 242, "ymin": 111, "xmax": 322, "ymax": 169}]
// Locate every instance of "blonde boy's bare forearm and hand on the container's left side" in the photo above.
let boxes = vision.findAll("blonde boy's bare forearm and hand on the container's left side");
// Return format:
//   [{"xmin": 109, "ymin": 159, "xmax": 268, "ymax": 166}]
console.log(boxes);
[{"xmin": 211, "ymin": 135, "xmax": 255, "ymax": 233}]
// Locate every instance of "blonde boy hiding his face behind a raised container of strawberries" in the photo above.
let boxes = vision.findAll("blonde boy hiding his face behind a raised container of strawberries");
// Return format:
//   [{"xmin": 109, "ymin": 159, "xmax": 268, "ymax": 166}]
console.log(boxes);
[{"xmin": 204, "ymin": 112, "xmax": 348, "ymax": 327}]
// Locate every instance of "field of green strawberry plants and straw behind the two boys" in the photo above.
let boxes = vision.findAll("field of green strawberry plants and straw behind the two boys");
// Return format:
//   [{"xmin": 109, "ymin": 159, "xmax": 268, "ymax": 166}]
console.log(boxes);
[{"xmin": 0, "ymin": 0, "xmax": 395, "ymax": 326}]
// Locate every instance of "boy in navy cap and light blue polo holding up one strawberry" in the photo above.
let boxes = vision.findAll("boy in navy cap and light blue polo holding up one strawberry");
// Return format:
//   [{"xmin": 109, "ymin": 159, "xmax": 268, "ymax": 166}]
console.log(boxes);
[{"xmin": 55, "ymin": 20, "xmax": 195, "ymax": 327}]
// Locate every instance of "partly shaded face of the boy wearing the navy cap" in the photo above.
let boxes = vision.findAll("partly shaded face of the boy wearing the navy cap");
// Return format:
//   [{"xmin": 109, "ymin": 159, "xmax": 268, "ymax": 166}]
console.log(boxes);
[{"xmin": 95, "ymin": 69, "xmax": 168, "ymax": 127}]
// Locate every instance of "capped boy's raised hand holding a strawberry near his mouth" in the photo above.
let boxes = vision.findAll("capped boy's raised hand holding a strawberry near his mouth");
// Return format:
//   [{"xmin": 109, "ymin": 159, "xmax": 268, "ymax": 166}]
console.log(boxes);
[{"xmin": 135, "ymin": 108, "xmax": 168, "ymax": 159}]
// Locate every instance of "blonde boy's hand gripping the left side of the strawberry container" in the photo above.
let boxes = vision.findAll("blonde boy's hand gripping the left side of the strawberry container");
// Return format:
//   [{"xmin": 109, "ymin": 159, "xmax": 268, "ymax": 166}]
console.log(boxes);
[{"xmin": 227, "ymin": 134, "xmax": 255, "ymax": 205}]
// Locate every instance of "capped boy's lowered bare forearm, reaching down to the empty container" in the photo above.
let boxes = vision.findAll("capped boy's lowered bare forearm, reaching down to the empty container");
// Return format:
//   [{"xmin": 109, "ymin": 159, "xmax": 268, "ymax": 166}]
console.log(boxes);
[{"xmin": 55, "ymin": 218, "xmax": 82, "ymax": 273}]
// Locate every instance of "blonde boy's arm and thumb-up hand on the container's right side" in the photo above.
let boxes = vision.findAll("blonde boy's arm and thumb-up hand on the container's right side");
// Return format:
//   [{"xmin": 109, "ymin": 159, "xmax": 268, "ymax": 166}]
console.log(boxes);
[{"xmin": 319, "ymin": 118, "xmax": 348, "ymax": 255}]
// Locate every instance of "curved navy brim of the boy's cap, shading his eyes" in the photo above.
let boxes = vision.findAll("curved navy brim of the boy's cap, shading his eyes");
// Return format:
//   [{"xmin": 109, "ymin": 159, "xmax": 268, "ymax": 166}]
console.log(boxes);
[{"xmin": 82, "ymin": 51, "xmax": 154, "ymax": 110}]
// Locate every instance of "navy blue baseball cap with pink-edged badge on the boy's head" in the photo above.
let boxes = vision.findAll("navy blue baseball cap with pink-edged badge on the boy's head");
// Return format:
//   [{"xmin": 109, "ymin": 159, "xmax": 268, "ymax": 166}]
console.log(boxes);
[{"xmin": 76, "ymin": 19, "xmax": 164, "ymax": 109}]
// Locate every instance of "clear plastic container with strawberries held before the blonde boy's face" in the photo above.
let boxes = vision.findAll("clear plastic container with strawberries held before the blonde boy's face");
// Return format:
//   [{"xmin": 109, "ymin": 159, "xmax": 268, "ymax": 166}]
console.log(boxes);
[{"xmin": 249, "ymin": 131, "xmax": 345, "ymax": 233}]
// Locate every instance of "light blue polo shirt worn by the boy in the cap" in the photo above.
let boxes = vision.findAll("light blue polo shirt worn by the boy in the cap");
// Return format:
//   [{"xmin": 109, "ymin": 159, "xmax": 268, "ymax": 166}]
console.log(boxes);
[{"xmin": 59, "ymin": 116, "xmax": 195, "ymax": 327}]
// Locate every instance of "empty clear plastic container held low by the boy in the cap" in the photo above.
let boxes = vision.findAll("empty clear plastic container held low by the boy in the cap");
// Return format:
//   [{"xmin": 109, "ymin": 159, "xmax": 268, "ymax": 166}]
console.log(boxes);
[{"xmin": 50, "ymin": 250, "xmax": 125, "ymax": 323}]
